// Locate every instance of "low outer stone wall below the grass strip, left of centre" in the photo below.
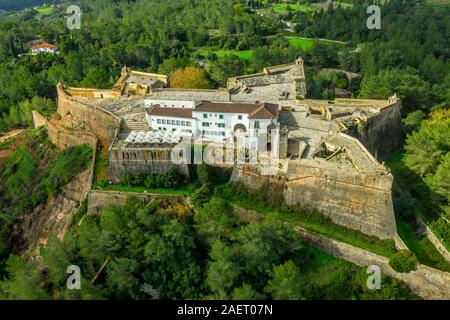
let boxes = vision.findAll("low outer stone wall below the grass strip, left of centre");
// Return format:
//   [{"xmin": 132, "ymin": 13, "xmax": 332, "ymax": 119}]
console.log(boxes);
[{"xmin": 88, "ymin": 190, "xmax": 189, "ymax": 214}]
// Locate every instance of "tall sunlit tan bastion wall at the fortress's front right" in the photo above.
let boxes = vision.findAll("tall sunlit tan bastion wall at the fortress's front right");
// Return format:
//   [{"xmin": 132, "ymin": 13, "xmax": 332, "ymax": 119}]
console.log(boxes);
[{"xmin": 232, "ymin": 164, "xmax": 397, "ymax": 239}]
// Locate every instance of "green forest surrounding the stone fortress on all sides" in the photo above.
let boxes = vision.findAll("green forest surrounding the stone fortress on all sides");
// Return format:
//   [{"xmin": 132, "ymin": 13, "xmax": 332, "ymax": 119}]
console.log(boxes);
[{"xmin": 0, "ymin": 0, "xmax": 450, "ymax": 299}]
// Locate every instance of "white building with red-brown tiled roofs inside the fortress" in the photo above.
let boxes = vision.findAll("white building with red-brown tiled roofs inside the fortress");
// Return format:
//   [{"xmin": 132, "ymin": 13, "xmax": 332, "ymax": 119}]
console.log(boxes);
[{"xmin": 146, "ymin": 100, "xmax": 279, "ymax": 141}]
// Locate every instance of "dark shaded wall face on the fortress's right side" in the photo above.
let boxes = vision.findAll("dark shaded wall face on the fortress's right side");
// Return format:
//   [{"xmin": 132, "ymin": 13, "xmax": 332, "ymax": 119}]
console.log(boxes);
[{"xmin": 349, "ymin": 101, "xmax": 404, "ymax": 159}]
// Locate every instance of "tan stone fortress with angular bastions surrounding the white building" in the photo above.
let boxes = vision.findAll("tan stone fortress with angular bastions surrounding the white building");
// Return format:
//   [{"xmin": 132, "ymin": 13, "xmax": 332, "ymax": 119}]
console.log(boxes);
[{"xmin": 47, "ymin": 59, "xmax": 402, "ymax": 239}]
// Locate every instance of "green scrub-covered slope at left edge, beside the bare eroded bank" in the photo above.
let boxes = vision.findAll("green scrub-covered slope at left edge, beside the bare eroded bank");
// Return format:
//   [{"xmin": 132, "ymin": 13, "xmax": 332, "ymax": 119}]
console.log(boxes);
[{"xmin": 0, "ymin": 129, "xmax": 92, "ymax": 274}]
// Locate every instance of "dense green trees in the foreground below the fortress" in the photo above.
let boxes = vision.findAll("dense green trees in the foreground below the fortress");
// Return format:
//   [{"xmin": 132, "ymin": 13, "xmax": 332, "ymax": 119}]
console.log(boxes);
[{"xmin": 0, "ymin": 198, "xmax": 417, "ymax": 300}]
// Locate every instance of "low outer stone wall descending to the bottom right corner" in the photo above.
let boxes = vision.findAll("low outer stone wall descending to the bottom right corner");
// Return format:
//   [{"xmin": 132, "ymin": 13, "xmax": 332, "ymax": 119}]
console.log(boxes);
[{"xmin": 295, "ymin": 227, "xmax": 450, "ymax": 300}]
